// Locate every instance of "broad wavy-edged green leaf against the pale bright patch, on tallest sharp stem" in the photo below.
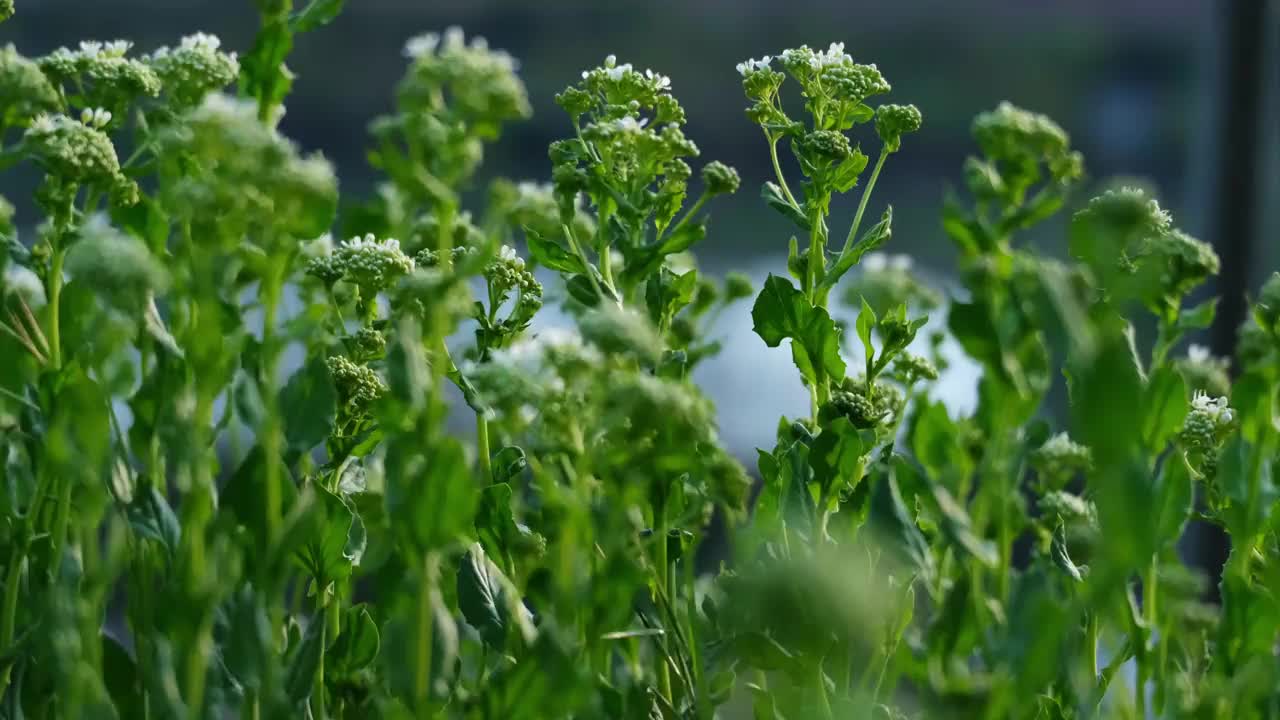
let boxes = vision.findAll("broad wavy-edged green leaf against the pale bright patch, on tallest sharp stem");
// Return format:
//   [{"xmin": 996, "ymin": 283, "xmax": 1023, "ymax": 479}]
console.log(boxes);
[{"xmin": 751, "ymin": 274, "xmax": 845, "ymax": 386}]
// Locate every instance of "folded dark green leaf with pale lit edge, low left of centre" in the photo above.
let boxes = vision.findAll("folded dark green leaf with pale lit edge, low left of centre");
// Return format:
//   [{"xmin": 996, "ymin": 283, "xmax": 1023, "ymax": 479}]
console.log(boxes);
[{"xmin": 458, "ymin": 543, "xmax": 534, "ymax": 651}]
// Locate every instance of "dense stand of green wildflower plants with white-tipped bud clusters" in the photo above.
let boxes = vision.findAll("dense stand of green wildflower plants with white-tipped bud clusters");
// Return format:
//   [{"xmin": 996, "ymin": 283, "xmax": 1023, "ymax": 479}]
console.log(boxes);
[{"xmin": 0, "ymin": 0, "xmax": 1280, "ymax": 720}]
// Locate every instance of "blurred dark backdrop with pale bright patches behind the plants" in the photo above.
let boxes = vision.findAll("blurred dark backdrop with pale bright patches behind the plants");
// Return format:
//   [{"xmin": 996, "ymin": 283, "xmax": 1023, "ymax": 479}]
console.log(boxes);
[{"xmin": 0, "ymin": 0, "xmax": 1280, "ymax": 457}]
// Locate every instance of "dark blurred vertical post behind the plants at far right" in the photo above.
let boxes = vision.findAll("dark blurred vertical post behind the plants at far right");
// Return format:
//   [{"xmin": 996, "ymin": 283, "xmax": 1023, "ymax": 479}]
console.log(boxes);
[{"xmin": 1198, "ymin": 0, "xmax": 1274, "ymax": 592}]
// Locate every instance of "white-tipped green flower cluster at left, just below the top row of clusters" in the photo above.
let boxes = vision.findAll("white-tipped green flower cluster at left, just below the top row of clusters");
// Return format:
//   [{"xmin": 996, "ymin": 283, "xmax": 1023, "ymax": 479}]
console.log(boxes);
[{"xmin": 23, "ymin": 114, "xmax": 138, "ymax": 205}]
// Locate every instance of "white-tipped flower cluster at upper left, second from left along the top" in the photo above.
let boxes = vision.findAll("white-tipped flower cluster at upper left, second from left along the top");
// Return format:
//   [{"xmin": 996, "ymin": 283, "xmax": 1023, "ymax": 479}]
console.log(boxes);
[{"xmin": 37, "ymin": 40, "xmax": 160, "ymax": 111}]
